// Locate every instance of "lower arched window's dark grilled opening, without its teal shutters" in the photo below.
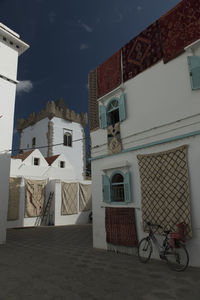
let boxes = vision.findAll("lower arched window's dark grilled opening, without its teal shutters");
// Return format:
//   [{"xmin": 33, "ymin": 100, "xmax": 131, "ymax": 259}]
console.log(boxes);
[{"xmin": 111, "ymin": 173, "xmax": 125, "ymax": 202}]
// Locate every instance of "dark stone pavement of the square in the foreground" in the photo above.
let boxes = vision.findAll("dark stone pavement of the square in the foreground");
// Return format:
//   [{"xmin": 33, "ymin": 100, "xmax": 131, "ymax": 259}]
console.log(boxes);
[{"xmin": 0, "ymin": 225, "xmax": 200, "ymax": 300}]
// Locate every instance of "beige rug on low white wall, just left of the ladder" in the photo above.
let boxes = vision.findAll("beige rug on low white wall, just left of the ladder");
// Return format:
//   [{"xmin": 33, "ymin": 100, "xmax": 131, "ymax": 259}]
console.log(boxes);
[{"xmin": 24, "ymin": 179, "xmax": 46, "ymax": 218}]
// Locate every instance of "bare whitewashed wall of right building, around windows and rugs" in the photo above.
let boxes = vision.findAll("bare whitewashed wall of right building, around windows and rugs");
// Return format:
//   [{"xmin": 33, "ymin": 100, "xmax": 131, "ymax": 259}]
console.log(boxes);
[{"xmin": 91, "ymin": 44, "xmax": 200, "ymax": 266}]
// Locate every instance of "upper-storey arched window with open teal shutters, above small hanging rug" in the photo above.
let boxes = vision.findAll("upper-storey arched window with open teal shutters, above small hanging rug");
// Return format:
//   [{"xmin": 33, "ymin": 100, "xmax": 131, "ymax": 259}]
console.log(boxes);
[{"xmin": 99, "ymin": 93, "xmax": 126, "ymax": 128}]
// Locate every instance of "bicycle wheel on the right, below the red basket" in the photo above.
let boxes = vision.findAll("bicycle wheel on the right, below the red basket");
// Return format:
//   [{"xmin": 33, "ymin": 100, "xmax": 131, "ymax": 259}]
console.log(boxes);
[{"xmin": 165, "ymin": 243, "xmax": 189, "ymax": 272}]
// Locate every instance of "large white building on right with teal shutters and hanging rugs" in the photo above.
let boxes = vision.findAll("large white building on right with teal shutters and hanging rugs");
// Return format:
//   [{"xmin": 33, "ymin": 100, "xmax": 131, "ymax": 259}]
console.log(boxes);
[{"xmin": 89, "ymin": 0, "xmax": 200, "ymax": 266}]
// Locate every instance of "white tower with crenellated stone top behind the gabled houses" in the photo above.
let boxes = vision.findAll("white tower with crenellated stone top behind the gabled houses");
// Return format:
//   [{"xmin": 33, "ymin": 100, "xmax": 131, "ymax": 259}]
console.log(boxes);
[{"xmin": 18, "ymin": 100, "xmax": 87, "ymax": 180}]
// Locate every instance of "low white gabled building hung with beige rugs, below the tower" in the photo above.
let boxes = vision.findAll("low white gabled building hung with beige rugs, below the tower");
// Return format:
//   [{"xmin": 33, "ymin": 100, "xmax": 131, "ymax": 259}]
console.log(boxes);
[{"xmin": 7, "ymin": 149, "xmax": 91, "ymax": 228}]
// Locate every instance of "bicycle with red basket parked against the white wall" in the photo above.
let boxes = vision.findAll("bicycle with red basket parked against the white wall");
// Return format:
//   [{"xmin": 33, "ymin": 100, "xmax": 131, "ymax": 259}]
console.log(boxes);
[{"xmin": 138, "ymin": 222, "xmax": 189, "ymax": 272}]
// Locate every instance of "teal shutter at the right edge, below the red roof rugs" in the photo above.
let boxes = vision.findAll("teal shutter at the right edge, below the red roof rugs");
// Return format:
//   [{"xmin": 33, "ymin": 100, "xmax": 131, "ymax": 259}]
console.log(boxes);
[{"xmin": 188, "ymin": 56, "xmax": 200, "ymax": 90}]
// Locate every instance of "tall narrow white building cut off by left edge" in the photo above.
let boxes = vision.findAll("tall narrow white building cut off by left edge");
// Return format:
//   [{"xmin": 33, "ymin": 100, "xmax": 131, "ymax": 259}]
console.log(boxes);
[{"xmin": 0, "ymin": 23, "xmax": 29, "ymax": 243}]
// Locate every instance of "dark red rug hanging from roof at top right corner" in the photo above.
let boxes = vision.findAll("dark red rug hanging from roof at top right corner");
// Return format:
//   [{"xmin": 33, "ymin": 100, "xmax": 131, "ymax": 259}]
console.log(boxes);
[{"xmin": 159, "ymin": 0, "xmax": 200, "ymax": 63}]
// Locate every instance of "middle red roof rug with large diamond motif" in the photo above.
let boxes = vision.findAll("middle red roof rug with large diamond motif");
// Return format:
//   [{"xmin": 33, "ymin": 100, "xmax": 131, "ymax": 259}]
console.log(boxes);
[{"xmin": 122, "ymin": 21, "xmax": 162, "ymax": 81}]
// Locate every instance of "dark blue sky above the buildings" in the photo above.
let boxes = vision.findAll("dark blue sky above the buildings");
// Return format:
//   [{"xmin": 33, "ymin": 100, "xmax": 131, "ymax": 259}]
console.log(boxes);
[{"xmin": 0, "ymin": 0, "xmax": 180, "ymax": 152}]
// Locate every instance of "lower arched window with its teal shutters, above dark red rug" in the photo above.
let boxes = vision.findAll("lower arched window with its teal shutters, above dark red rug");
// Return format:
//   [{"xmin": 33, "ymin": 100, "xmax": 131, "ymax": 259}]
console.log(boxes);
[{"xmin": 102, "ymin": 170, "xmax": 132, "ymax": 205}]
